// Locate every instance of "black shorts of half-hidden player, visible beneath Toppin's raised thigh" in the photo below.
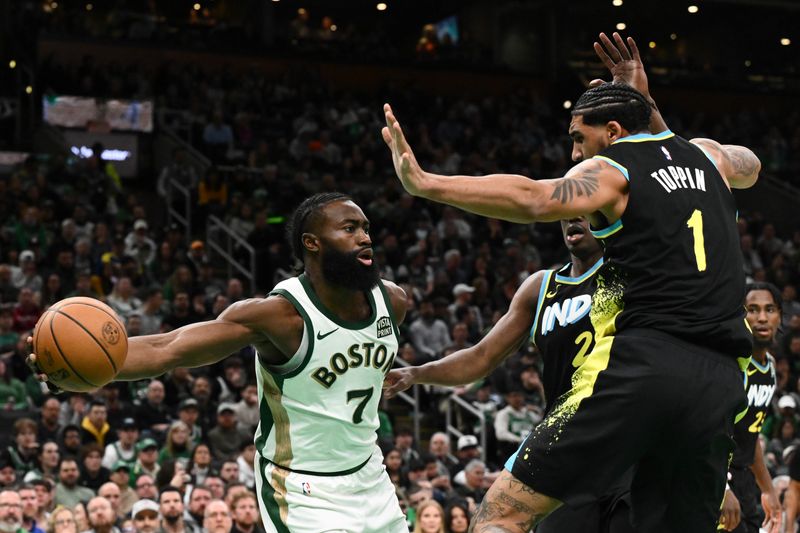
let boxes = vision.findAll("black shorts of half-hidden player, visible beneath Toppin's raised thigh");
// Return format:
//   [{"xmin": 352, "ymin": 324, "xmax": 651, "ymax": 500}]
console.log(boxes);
[{"xmin": 534, "ymin": 470, "xmax": 634, "ymax": 533}]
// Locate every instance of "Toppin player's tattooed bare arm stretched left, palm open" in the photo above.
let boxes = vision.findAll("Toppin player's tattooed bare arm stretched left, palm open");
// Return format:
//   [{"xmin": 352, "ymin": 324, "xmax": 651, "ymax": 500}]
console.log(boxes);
[{"xmin": 382, "ymin": 104, "xmax": 628, "ymax": 223}]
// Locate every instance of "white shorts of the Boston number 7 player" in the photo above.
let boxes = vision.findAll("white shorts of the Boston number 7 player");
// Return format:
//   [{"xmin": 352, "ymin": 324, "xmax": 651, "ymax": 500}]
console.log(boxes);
[{"xmin": 255, "ymin": 446, "xmax": 408, "ymax": 533}]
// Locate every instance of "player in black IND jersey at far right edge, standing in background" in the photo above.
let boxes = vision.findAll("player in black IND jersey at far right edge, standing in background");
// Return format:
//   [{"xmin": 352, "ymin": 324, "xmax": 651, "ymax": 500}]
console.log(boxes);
[{"xmin": 729, "ymin": 283, "xmax": 782, "ymax": 533}]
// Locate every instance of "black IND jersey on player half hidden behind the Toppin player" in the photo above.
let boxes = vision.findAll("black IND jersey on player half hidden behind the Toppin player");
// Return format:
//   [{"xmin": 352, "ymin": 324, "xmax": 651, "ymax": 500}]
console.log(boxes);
[{"xmin": 531, "ymin": 258, "xmax": 603, "ymax": 413}]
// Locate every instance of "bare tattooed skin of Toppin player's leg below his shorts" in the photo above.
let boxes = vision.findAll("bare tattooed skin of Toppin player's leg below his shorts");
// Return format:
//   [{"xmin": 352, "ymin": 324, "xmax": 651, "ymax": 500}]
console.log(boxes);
[{"xmin": 470, "ymin": 470, "xmax": 561, "ymax": 533}]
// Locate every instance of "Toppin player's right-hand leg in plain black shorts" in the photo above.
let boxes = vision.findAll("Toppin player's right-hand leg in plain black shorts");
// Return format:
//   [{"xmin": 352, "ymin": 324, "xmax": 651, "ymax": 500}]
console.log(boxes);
[{"xmin": 631, "ymin": 338, "xmax": 745, "ymax": 533}]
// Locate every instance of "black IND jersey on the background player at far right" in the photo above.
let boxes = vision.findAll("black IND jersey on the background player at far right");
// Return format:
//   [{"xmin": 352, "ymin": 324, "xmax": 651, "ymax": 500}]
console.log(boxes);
[{"xmin": 731, "ymin": 354, "xmax": 777, "ymax": 468}]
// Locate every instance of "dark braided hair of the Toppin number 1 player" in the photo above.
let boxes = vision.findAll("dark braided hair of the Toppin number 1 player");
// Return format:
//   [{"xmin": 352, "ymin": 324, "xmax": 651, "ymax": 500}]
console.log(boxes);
[{"xmin": 572, "ymin": 83, "xmax": 652, "ymax": 133}]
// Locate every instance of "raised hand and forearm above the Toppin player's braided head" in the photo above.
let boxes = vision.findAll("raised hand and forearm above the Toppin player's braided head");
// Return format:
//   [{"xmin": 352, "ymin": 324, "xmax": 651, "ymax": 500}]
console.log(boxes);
[{"xmin": 590, "ymin": 32, "xmax": 669, "ymax": 133}]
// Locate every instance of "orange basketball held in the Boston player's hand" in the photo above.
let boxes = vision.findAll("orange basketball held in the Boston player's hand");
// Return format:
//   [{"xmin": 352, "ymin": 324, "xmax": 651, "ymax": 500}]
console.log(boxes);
[{"xmin": 33, "ymin": 296, "xmax": 128, "ymax": 392}]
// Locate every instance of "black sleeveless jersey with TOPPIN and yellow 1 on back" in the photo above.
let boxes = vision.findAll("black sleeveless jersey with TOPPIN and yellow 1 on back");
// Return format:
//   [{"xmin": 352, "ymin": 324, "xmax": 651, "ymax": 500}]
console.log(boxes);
[{"xmin": 592, "ymin": 131, "xmax": 752, "ymax": 364}]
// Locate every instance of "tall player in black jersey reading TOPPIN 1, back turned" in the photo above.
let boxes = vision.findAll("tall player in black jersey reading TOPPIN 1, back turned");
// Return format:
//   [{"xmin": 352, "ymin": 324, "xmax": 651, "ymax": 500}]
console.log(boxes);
[{"xmin": 382, "ymin": 31, "xmax": 761, "ymax": 533}]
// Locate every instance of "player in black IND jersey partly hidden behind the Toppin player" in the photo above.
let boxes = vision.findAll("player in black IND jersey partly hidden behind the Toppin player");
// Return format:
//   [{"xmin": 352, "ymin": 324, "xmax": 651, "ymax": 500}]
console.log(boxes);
[{"xmin": 385, "ymin": 217, "xmax": 633, "ymax": 533}]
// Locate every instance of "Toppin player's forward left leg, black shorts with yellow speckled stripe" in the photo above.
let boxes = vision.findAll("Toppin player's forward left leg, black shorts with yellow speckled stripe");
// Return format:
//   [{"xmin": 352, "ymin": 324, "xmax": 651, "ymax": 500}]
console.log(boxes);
[{"xmin": 494, "ymin": 337, "xmax": 671, "ymax": 531}]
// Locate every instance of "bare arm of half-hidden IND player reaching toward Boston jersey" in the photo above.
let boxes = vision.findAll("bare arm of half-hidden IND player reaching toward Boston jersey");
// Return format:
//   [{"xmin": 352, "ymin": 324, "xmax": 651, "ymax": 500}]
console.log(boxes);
[{"xmin": 383, "ymin": 272, "xmax": 544, "ymax": 392}]
